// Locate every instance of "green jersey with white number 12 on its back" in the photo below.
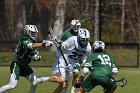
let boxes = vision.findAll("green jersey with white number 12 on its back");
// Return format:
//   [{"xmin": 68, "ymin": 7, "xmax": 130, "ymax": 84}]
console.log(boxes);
[{"xmin": 85, "ymin": 53, "xmax": 116, "ymax": 77}]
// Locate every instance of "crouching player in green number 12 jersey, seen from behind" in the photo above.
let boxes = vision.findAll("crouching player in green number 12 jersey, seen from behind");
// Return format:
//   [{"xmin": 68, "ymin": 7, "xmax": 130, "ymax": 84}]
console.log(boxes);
[{"xmin": 76, "ymin": 41, "xmax": 118, "ymax": 93}]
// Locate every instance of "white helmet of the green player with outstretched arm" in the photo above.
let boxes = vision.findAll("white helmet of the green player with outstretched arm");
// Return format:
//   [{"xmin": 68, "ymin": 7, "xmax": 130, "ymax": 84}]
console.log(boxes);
[{"xmin": 24, "ymin": 25, "xmax": 38, "ymax": 40}]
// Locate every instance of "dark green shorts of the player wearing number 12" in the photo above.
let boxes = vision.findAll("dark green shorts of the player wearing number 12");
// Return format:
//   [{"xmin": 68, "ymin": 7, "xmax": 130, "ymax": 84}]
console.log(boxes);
[{"xmin": 81, "ymin": 74, "xmax": 116, "ymax": 92}]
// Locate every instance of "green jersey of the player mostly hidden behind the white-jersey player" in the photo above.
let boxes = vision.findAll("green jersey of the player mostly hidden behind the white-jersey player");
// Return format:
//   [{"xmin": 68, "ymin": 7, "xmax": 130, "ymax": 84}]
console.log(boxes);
[{"xmin": 61, "ymin": 28, "xmax": 77, "ymax": 41}]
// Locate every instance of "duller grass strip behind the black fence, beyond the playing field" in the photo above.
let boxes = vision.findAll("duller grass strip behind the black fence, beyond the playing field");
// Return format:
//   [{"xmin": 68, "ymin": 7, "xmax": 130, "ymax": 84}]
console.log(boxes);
[{"xmin": 0, "ymin": 47, "xmax": 138, "ymax": 66}]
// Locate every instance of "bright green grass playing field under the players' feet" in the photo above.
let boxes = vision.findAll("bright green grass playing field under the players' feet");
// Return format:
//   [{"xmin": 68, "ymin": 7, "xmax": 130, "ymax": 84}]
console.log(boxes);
[{"xmin": 0, "ymin": 66, "xmax": 140, "ymax": 93}]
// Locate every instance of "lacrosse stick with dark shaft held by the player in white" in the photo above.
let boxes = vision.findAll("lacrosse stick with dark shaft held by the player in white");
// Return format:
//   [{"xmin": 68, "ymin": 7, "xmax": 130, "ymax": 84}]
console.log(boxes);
[{"xmin": 49, "ymin": 27, "xmax": 68, "ymax": 66}]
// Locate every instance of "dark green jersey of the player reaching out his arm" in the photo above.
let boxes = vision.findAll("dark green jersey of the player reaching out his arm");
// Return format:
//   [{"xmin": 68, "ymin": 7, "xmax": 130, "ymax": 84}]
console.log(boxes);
[{"xmin": 16, "ymin": 35, "xmax": 37, "ymax": 66}]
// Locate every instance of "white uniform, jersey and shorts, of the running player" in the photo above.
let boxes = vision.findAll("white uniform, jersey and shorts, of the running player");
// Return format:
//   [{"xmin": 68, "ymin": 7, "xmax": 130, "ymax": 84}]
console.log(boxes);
[{"xmin": 52, "ymin": 36, "xmax": 91, "ymax": 80}]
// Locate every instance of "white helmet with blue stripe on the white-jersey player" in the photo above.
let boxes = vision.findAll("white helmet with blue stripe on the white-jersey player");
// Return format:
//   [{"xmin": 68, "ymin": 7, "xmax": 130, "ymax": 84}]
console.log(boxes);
[{"xmin": 78, "ymin": 28, "xmax": 90, "ymax": 46}]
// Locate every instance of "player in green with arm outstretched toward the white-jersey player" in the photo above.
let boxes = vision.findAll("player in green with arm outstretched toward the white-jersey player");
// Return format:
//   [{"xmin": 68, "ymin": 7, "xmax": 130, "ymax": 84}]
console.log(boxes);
[{"xmin": 0, "ymin": 25, "xmax": 53, "ymax": 93}]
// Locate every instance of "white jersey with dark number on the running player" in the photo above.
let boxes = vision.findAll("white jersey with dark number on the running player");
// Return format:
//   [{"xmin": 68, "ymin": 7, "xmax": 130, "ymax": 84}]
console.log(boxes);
[{"xmin": 59, "ymin": 36, "xmax": 91, "ymax": 64}]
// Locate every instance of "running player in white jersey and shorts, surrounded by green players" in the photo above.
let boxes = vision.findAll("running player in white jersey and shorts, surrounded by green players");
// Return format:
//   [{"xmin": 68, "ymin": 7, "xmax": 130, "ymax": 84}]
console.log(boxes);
[{"xmin": 33, "ymin": 28, "xmax": 91, "ymax": 93}]
